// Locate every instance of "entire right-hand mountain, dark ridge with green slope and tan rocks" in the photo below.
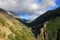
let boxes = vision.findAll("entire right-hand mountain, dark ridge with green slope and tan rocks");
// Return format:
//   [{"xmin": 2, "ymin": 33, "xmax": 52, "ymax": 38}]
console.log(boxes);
[{"xmin": 29, "ymin": 7, "xmax": 60, "ymax": 40}]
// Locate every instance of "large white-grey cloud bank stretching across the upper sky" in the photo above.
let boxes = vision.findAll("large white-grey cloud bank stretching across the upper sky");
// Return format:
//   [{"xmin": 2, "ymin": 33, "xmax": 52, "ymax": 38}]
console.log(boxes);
[{"xmin": 0, "ymin": 0, "xmax": 56, "ymax": 14}]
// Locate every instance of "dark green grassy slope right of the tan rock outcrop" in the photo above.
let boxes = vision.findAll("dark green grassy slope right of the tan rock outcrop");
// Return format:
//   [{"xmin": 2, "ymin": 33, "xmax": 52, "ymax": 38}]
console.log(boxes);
[{"xmin": 46, "ymin": 17, "xmax": 60, "ymax": 40}]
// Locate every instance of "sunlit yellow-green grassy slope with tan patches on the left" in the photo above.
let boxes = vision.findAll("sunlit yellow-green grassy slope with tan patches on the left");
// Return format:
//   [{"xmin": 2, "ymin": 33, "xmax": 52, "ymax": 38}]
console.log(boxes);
[{"xmin": 0, "ymin": 11, "xmax": 34, "ymax": 40}]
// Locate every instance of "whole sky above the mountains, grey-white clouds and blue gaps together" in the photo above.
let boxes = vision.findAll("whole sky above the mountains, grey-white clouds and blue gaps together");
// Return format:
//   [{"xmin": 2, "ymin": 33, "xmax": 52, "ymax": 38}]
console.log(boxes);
[{"xmin": 0, "ymin": 0, "xmax": 60, "ymax": 20}]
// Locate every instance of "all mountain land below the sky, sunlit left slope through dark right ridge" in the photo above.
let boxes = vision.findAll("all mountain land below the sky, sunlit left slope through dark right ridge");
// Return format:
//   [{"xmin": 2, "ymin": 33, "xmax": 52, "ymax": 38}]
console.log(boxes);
[{"xmin": 0, "ymin": 7, "xmax": 60, "ymax": 40}]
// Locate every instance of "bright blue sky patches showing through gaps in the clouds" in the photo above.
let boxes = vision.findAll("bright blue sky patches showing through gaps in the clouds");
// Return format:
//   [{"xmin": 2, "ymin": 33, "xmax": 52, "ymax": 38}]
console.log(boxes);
[{"xmin": 21, "ymin": 0, "xmax": 60, "ymax": 19}]
